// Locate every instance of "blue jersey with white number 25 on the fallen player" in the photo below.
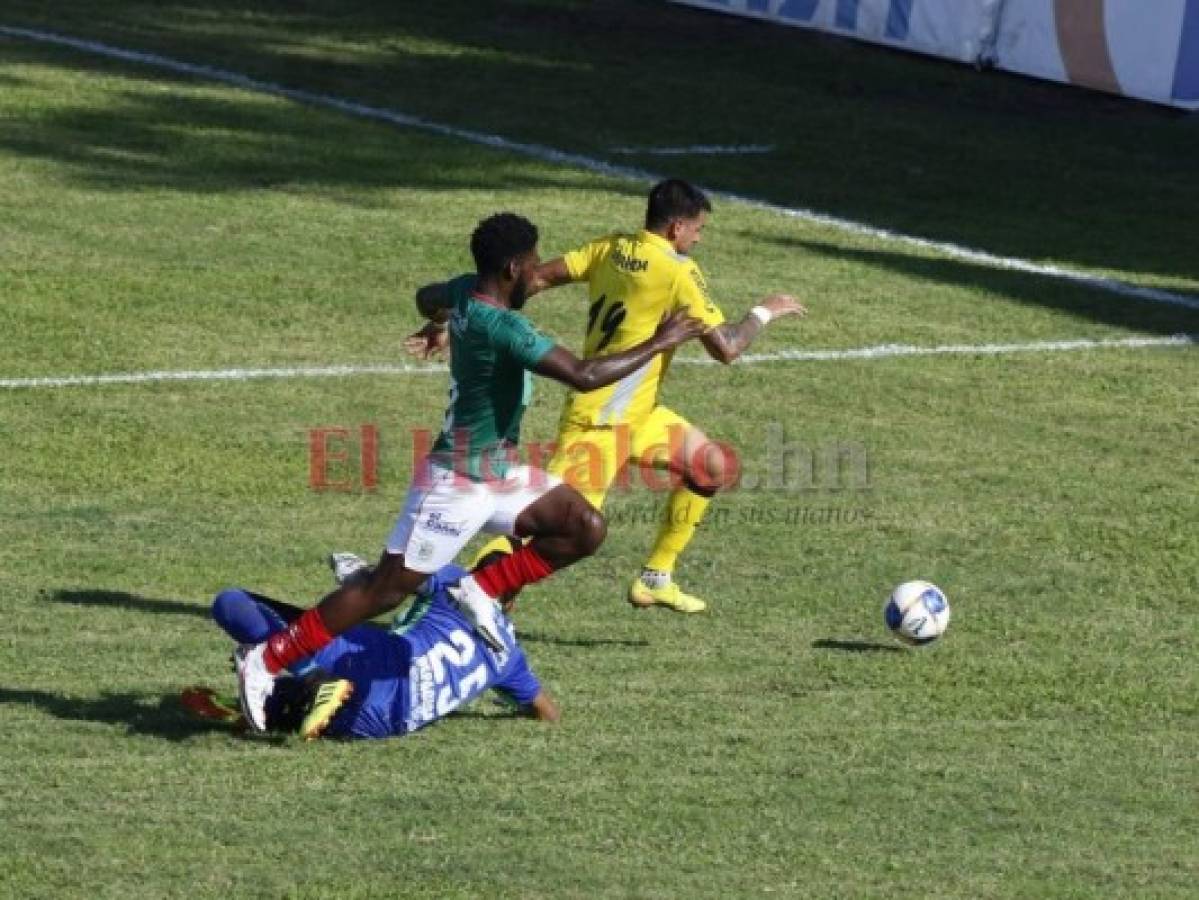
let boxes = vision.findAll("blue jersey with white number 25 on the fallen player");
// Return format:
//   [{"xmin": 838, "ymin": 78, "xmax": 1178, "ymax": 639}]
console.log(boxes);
[{"xmin": 314, "ymin": 591, "xmax": 541, "ymax": 737}]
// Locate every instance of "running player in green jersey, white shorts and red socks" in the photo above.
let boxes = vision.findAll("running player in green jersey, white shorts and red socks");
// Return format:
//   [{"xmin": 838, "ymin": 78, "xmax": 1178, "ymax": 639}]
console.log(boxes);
[{"xmin": 237, "ymin": 213, "xmax": 704, "ymax": 730}]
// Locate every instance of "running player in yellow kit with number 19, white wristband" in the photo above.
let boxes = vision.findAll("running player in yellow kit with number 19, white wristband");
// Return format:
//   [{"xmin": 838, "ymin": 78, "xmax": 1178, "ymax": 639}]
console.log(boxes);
[{"xmin": 465, "ymin": 179, "xmax": 807, "ymax": 612}]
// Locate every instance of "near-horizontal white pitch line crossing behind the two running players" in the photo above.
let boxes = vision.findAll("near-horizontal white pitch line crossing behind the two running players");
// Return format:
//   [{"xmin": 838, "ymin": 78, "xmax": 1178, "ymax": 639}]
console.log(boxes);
[{"xmin": 0, "ymin": 334, "xmax": 1199, "ymax": 391}]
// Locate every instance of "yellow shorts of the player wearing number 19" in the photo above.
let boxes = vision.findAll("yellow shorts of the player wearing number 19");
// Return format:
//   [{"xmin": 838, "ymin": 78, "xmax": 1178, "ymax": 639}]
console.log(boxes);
[{"xmin": 546, "ymin": 406, "xmax": 691, "ymax": 509}]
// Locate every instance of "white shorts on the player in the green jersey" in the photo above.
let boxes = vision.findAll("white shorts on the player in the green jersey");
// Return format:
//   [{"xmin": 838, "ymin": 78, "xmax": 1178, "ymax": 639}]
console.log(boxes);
[{"xmin": 387, "ymin": 460, "xmax": 562, "ymax": 573}]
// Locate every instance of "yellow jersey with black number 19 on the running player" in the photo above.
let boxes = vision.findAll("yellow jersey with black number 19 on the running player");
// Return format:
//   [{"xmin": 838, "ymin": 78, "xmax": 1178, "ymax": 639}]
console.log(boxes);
[{"xmin": 562, "ymin": 229, "xmax": 724, "ymax": 427}]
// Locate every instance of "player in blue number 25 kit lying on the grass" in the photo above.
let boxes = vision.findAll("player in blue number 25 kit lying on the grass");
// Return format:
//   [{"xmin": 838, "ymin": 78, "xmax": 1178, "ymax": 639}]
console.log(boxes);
[{"xmin": 182, "ymin": 566, "xmax": 560, "ymax": 739}]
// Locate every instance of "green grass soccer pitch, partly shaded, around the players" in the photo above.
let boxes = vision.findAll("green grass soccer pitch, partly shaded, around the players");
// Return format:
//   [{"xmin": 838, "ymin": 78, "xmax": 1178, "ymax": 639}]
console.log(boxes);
[{"xmin": 0, "ymin": 0, "xmax": 1199, "ymax": 898}]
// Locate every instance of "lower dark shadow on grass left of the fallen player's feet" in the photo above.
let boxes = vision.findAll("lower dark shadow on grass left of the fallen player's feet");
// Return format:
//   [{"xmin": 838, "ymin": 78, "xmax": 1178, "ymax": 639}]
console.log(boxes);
[{"xmin": 0, "ymin": 688, "xmax": 249, "ymax": 741}]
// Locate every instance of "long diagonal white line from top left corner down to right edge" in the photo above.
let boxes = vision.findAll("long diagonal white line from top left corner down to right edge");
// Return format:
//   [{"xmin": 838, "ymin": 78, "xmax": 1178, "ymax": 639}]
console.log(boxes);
[{"xmin": 7, "ymin": 25, "xmax": 1199, "ymax": 309}]
